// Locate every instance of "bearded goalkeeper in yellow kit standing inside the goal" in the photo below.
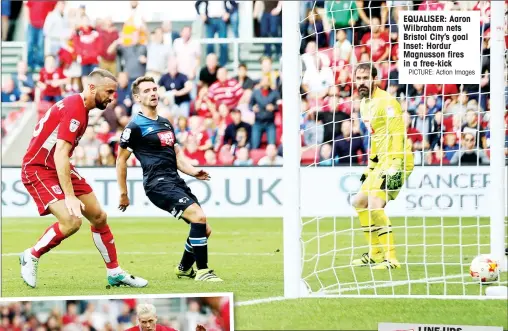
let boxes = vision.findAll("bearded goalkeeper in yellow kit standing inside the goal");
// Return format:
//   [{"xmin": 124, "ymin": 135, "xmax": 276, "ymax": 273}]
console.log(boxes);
[{"xmin": 352, "ymin": 63, "xmax": 414, "ymax": 269}]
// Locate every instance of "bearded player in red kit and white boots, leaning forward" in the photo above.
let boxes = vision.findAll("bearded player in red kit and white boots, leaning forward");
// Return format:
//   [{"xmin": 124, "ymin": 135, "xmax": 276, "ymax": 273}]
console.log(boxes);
[{"xmin": 20, "ymin": 69, "xmax": 148, "ymax": 287}]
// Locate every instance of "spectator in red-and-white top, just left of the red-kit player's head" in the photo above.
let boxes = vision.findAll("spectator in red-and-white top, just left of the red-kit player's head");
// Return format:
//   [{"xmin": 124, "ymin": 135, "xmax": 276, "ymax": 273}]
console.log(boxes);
[{"xmin": 37, "ymin": 55, "xmax": 68, "ymax": 102}]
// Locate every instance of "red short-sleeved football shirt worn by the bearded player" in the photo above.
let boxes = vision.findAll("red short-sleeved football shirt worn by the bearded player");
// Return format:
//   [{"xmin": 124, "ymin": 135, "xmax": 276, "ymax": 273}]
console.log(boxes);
[{"xmin": 23, "ymin": 94, "xmax": 88, "ymax": 170}]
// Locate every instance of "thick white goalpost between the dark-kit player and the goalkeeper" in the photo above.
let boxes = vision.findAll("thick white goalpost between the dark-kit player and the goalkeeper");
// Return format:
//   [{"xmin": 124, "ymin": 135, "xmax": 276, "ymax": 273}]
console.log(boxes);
[{"xmin": 281, "ymin": 1, "xmax": 303, "ymax": 298}]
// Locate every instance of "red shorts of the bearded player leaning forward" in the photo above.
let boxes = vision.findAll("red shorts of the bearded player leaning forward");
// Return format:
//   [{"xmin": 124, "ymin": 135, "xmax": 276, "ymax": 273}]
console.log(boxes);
[{"xmin": 21, "ymin": 168, "xmax": 93, "ymax": 216}]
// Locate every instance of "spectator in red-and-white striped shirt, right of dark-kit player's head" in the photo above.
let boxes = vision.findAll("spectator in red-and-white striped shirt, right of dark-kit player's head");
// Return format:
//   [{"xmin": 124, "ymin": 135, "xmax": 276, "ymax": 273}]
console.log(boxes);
[{"xmin": 208, "ymin": 67, "xmax": 243, "ymax": 109}]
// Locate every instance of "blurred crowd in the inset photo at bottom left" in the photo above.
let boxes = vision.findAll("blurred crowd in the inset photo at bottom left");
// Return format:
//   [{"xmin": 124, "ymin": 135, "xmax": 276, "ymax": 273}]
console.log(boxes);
[{"xmin": 0, "ymin": 298, "xmax": 221, "ymax": 331}]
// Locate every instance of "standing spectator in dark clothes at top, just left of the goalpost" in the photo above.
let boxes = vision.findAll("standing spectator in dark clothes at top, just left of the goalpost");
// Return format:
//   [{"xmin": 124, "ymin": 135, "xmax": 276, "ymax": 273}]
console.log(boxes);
[{"xmin": 260, "ymin": 1, "xmax": 282, "ymax": 58}]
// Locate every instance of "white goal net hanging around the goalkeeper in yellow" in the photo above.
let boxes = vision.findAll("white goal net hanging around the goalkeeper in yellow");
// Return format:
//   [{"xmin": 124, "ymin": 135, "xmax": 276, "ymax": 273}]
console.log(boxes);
[{"xmin": 283, "ymin": 1, "xmax": 508, "ymax": 297}]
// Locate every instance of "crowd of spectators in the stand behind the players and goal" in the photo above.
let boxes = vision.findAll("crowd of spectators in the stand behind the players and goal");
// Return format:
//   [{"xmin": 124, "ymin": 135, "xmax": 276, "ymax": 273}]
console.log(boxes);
[{"xmin": 2, "ymin": 0, "xmax": 508, "ymax": 166}]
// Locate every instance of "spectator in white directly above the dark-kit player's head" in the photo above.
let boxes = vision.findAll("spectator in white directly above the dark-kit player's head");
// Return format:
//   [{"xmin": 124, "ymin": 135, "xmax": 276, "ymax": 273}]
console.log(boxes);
[{"xmin": 146, "ymin": 28, "xmax": 172, "ymax": 82}]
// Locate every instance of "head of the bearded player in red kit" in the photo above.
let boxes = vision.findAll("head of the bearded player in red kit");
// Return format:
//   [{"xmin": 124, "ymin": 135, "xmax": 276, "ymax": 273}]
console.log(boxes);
[{"xmin": 83, "ymin": 69, "xmax": 118, "ymax": 110}]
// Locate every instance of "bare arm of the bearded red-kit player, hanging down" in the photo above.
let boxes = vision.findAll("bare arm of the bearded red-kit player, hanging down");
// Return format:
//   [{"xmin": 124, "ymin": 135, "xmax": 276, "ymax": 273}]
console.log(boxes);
[{"xmin": 54, "ymin": 139, "xmax": 85, "ymax": 218}]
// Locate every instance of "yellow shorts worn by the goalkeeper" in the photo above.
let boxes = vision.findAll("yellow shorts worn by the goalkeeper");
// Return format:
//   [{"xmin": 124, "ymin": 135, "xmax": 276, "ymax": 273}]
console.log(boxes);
[{"xmin": 360, "ymin": 154, "xmax": 414, "ymax": 202}]
